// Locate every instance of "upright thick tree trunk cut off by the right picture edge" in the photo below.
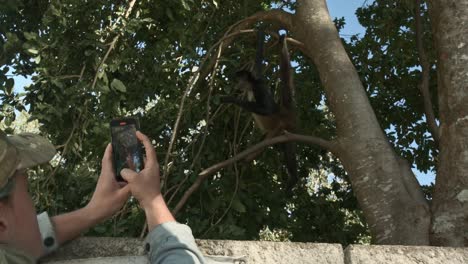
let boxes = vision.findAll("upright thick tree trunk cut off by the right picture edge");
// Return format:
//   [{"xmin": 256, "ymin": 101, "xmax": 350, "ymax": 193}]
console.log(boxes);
[{"xmin": 429, "ymin": 0, "xmax": 468, "ymax": 246}]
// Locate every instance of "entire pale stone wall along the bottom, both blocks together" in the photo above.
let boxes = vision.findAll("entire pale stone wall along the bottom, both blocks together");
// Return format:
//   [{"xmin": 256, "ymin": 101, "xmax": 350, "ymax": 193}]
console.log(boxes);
[{"xmin": 45, "ymin": 237, "xmax": 468, "ymax": 264}]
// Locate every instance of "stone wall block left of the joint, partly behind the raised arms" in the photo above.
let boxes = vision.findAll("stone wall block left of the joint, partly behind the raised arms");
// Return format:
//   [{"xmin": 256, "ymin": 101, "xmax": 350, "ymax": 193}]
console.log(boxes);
[{"xmin": 45, "ymin": 237, "xmax": 344, "ymax": 264}]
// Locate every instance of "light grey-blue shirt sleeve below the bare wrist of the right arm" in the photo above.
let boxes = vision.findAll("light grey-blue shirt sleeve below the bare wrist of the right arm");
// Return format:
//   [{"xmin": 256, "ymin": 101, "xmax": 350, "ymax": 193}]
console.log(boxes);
[{"xmin": 145, "ymin": 222, "xmax": 206, "ymax": 264}]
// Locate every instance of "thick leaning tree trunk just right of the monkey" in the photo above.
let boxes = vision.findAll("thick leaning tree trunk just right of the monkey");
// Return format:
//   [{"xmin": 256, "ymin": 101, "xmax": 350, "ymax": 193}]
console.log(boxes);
[{"xmin": 290, "ymin": 0, "xmax": 430, "ymax": 245}]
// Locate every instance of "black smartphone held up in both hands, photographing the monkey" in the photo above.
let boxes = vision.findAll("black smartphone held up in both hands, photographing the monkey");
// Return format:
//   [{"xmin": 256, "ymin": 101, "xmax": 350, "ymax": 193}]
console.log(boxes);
[{"xmin": 110, "ymin": 118, "xmax": 143, "ymax": 181}]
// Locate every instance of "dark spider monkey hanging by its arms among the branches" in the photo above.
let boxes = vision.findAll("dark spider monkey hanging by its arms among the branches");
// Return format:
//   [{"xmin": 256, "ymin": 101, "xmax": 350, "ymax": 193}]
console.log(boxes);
[{"xmin": 221, "ymin": 30, "xmax": 298, "ymax": 194}]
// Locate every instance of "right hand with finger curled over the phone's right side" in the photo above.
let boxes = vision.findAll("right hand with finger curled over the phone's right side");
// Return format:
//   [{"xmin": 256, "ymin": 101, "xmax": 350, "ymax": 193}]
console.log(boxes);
[{"xmin": 120, "ymin": 131, "xmax": 161, "ymax": 210}]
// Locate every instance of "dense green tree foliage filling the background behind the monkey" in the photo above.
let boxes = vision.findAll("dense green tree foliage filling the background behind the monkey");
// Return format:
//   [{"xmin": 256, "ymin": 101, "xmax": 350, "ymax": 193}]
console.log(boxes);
[{"xmin": 0, "ymin": 0, "xmax": 450, "ymax": 244}]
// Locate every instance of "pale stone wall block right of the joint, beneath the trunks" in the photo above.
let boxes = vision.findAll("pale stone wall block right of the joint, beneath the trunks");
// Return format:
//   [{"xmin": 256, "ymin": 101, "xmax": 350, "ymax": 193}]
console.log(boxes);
[{"xmin": 345, "ymin": 245, "xmax": 468, "ymax": 264}]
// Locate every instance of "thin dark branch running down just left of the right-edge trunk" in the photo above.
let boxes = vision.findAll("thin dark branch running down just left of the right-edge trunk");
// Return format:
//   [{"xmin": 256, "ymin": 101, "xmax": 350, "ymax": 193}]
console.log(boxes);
[{"xmin": 415, "ymin": 0, "xmax": 440, "ymax": 145}]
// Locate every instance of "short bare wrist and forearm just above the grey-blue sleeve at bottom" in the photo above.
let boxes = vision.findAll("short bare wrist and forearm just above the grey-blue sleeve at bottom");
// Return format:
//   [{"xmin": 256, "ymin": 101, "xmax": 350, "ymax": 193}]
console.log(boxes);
[{"xmin": 144, "ymin": 195, "xmax": 175, "ymax": 231}]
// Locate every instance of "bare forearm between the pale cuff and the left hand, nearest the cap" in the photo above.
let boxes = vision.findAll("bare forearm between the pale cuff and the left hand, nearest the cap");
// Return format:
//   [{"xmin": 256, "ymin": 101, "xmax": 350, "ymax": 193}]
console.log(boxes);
[{"xmin": 51, "ymin": 207, "xmax": 101, "ymax": 245}]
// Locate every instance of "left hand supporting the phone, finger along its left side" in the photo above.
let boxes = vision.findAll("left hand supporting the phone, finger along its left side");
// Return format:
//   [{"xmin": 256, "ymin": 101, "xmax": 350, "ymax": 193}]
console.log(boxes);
[{"xmin": 86, "ymin": 144, "xmax": 130, "ymax": 222}]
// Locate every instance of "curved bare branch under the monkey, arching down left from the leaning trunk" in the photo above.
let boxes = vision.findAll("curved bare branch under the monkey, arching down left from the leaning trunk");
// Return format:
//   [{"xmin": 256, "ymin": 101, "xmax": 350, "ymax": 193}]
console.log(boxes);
[{"xmin": 172, "ymin": 132, "xmax": 339, "ymax": 215}]
